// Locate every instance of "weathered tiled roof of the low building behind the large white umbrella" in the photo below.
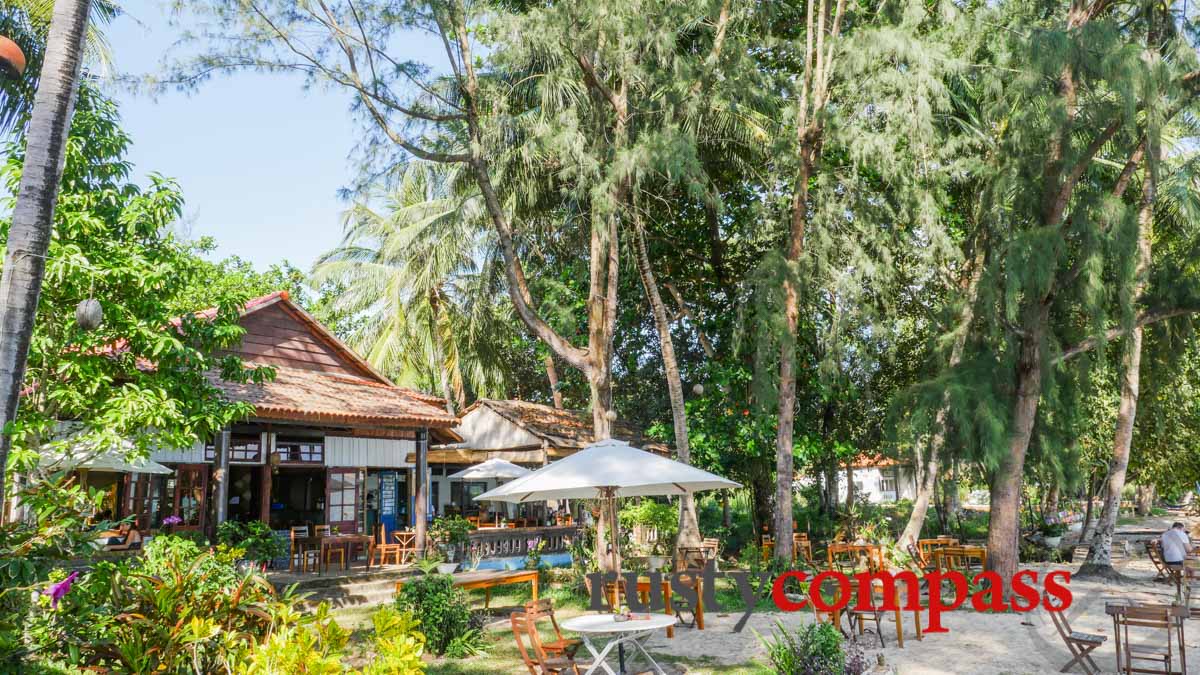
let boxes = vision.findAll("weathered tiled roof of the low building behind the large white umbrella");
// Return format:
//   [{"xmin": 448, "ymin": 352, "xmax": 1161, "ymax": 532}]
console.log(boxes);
[{"xmin": 462, "ymin": 399, "xmax": 668, "ymax": 453}]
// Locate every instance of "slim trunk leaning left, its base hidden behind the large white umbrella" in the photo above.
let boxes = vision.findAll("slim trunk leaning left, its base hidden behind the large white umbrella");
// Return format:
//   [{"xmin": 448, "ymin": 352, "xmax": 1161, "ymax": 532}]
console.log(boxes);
[{"xmin": 630, "ymin": 210, "xmax": 701, "ymax": 548}]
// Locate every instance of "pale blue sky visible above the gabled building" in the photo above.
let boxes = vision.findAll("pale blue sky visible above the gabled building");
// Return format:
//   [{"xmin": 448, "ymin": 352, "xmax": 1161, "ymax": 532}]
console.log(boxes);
[{"xmin": 106, "ymin": 0, "xmax": 436, "ymax": 270}]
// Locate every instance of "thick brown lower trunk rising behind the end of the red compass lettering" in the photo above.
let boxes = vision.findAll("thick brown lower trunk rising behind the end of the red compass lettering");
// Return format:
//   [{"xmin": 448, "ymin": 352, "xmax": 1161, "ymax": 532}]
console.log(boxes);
[{"xmin": 988, "ymin": 303, "xmax": 1049, "ymax": 595}]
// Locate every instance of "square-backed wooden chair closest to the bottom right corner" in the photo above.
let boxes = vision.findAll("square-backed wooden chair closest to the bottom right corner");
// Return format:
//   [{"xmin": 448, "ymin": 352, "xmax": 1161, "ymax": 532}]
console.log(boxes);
[{"xmin": 1105, "ymin": 605, "xmax": 1187, "ymax": 675}]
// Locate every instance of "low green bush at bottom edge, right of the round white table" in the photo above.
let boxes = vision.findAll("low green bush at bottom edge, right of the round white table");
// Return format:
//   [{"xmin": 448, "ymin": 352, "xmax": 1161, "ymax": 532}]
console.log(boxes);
[{"xmin": 760, "ymin": 622, "xmax": 866, "ymax": 675}]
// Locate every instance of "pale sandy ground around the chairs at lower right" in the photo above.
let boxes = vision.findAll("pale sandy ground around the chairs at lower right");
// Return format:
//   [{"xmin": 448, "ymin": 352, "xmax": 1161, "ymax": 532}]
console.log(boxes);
[{"xmin": 624, "ymin": 511, "xmax": 1200, "ymax": 675}]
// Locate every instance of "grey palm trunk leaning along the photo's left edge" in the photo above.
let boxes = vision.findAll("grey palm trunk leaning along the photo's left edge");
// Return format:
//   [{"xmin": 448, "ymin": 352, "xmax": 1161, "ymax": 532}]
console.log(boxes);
[{"xmin": 0, "ymin": 0, "xmax": 90, "ymax": 512}]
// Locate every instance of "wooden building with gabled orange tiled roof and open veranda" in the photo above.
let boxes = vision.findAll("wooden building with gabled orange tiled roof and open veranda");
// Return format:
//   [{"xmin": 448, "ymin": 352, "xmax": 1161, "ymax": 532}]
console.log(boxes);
[{"xmin": 120, "ymin": 292, "xmax": 460, "ymax": 532}]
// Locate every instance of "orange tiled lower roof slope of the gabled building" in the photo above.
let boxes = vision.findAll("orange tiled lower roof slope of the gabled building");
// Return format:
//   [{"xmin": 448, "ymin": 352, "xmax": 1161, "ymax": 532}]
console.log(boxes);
[{"xmin": 210, "ymin": 366, "xmax": 458, "ymax": 429}]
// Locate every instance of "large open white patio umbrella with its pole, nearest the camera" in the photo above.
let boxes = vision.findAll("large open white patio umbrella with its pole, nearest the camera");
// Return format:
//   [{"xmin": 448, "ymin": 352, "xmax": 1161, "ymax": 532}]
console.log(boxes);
[{"xmin": 475, "ymin": 438, "xmax": 740, "ymax": 569}]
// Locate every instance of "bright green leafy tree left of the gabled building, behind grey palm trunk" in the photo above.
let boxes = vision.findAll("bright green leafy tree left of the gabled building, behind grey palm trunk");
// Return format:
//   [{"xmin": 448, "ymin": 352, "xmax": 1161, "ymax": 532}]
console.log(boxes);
[{"xmin": 0, "ymin": 84, "xmax": 272, "ymax": 482}]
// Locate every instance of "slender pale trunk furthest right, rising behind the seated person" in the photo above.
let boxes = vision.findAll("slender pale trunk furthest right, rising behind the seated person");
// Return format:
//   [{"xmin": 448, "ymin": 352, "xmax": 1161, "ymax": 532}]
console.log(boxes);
[{"xmin": 1079, "ymin": 154, "xmax": 1157, "ymax": 578}]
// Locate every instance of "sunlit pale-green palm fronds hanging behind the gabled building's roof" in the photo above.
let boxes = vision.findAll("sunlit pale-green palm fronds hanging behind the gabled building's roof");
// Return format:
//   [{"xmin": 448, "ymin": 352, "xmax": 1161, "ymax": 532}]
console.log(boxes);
[{"xmin": 312, "ymin": 162, "xmax": 512, "ymax": 413}]
